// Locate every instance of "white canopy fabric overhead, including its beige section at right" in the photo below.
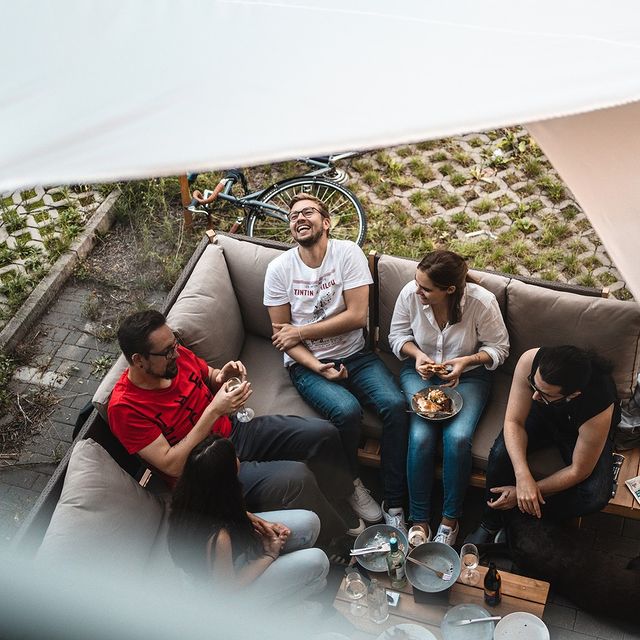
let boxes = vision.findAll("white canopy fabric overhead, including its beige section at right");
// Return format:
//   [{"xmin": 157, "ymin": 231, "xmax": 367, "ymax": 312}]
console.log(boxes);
[{"xmin": 0, "ymin": 0, "xmax": 640, "ymax": 298}]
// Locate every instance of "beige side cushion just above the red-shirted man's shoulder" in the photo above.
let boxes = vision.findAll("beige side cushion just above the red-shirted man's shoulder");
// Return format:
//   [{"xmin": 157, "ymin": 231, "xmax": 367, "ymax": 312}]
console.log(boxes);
[{"xmin": 167, "ymin": 244, "xmax": 245, "ymax": 367}]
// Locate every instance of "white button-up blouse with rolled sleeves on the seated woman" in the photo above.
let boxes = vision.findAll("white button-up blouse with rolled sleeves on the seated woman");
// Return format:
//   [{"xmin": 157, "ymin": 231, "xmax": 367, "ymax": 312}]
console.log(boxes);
[{"xmin": 389, "ymin": 280, "xmax": 509, "ymax": 371}]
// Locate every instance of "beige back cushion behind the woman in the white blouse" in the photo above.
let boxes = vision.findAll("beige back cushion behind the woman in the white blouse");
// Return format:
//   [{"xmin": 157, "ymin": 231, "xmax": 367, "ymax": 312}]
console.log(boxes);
[{"xmin": 378, "ymin": 255, "xmax": 509, "ymax": 351}]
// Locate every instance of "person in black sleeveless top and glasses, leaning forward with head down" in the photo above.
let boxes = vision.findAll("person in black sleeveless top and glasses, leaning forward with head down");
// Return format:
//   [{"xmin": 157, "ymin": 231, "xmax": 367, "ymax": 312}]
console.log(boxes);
[{"xmin": 466, "ymin": 346, "xmax": 620, "ymax": 544}]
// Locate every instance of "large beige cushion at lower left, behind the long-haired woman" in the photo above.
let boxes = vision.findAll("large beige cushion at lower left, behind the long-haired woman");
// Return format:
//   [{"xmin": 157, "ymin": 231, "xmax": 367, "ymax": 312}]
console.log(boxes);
[{"xmin": 37, "ymin": 440, "xmax": 165, "ymax": 573}]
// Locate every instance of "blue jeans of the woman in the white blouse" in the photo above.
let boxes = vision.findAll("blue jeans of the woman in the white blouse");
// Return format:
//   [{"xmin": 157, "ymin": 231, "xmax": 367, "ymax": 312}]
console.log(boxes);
[{"xmin": 400, "ymin": 358, "xmax": 491, "ymax": 522}]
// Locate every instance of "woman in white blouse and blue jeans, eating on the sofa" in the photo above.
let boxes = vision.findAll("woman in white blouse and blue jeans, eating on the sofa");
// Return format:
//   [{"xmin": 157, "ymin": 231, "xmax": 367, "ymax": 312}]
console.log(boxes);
[{"xmin": 389, "ymin": 250, "xmax": 509, "ymax": 545}]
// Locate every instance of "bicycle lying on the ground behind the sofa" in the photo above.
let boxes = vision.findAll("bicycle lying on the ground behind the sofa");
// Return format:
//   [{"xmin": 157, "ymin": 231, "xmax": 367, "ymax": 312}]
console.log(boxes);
[{"xmin": 187, "ymin": 152, "xmax": 367, "ymax": 246}]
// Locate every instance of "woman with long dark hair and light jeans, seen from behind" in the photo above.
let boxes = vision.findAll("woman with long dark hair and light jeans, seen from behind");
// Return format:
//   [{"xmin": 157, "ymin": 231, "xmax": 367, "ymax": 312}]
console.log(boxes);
[{"xmin": 168, "ymin": 434, "xmax": 329, "ymax": 605}]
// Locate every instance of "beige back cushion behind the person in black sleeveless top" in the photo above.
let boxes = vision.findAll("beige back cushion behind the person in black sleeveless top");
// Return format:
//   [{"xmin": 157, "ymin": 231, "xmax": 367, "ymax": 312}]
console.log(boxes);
[{"xmin": 504, "ymin": 280, "xmax": 640, "ymax": 398}]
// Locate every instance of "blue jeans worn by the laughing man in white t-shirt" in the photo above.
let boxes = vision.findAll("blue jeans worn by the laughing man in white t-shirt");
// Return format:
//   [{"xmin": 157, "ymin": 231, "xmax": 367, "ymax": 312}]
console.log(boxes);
[{"xmin": 289, "ymin": 351, "xmax": 409, "ymax": 507}]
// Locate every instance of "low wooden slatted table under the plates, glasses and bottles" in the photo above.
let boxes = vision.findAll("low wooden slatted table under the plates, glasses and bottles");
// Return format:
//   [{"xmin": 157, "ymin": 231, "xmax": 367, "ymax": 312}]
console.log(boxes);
[{"xmin": 333, "ymin": 567, "xmax": 549, "ymax": 639}]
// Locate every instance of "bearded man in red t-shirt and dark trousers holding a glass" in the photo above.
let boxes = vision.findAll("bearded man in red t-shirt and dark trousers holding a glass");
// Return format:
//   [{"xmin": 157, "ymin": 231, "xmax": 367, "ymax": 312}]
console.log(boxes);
[{"xmin": 108, "ymin": 310, "xmax": 364, "ymax": 540}]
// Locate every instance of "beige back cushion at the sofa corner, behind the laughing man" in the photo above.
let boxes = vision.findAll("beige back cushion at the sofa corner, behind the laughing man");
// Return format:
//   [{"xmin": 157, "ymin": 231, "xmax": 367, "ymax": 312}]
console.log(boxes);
[{"xmin": 217, "ymin": 235, "xmax": 282, "ymax": 339}]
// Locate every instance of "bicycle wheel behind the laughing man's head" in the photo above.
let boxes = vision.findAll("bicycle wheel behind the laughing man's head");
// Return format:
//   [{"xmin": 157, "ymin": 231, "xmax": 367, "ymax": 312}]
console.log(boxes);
[{"xmin": 247, "ymin": 177, "xmax": 367, "ymax": 246}]
